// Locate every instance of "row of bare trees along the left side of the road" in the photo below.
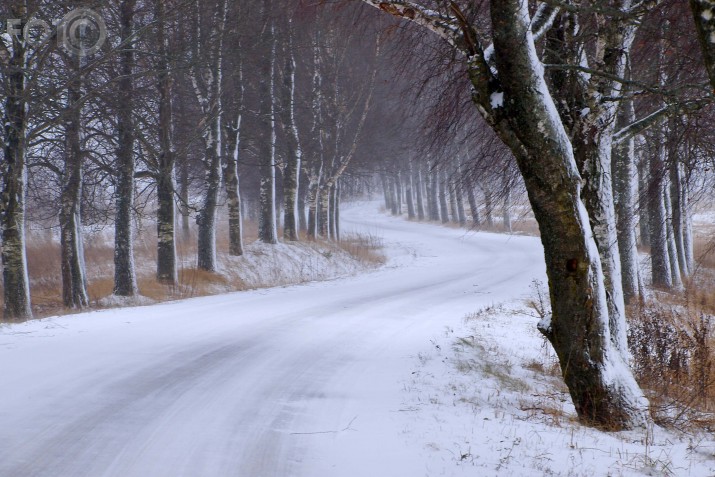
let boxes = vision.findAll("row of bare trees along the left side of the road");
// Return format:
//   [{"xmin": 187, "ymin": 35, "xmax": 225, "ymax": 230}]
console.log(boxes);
[{"xmin": 0, "ymin": 0, "xmax": 381, "ymax": 321}]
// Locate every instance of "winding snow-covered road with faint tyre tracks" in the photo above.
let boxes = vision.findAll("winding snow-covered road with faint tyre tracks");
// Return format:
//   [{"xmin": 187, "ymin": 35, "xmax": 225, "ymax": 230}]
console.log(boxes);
[{"xmin": 0, "ymin": 204, "xmax": 544, "ymax": 477}]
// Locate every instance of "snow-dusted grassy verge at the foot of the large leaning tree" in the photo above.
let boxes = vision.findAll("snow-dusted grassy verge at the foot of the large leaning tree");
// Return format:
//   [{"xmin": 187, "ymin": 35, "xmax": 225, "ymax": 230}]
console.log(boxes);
[{"xmin": 404, "ymin": 306, "xmax": 715, "ymax": 476}]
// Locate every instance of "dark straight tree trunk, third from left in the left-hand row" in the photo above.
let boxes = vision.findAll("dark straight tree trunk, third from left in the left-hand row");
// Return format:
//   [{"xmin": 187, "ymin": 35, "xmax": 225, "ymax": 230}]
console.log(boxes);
[{"xmin": 114, "ymin": 0, "xmax": 137, "ymax": 296}]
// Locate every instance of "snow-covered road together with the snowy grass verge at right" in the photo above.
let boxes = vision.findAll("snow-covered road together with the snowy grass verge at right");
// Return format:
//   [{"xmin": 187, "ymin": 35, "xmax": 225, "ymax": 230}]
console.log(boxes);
[{"xmin": 0, "ymin": 204, "xmax": 715, "ymax": 477}]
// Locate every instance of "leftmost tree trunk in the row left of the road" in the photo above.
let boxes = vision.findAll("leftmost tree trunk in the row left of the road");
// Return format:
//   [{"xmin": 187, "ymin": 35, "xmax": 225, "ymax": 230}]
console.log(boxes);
[{"xmin": 0, "ymin": 8, "xmax": 32, "ymax": 322}]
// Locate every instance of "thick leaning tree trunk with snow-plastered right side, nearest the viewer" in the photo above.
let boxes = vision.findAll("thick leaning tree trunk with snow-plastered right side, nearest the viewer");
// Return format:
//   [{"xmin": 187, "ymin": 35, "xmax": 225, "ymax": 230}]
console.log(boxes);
[{"xmin": 492, "ymin": 0, "xmax": 648, "ymax": 429}]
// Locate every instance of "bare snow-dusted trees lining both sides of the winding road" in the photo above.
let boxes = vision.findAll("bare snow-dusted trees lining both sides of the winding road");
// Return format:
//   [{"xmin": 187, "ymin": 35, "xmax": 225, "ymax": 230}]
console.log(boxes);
[{"xmin": 0, "ymin": 0, "xmax": 715, "ymax": 429}]
